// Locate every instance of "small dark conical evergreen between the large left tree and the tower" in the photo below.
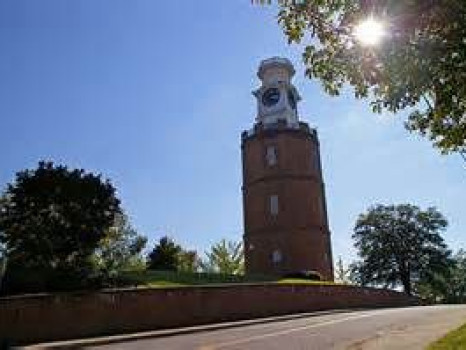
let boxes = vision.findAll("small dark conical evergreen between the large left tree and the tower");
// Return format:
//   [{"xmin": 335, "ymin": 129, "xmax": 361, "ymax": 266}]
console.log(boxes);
[{"xmin": 147, "ymin": 236, "xmax": 183, "ymax": 271}]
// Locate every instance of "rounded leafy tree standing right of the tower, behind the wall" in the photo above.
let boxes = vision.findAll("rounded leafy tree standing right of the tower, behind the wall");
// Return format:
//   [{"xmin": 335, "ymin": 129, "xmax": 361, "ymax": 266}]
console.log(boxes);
[{"xmin": 352, "ymin": 204, "xmax": 450, "ymax": 294}]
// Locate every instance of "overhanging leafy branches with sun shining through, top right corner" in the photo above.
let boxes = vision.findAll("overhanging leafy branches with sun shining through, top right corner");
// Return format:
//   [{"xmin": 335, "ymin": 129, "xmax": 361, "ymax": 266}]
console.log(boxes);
[{"xmin": 255, "ymin": 0, "xmax": 466, "ymax": 156}]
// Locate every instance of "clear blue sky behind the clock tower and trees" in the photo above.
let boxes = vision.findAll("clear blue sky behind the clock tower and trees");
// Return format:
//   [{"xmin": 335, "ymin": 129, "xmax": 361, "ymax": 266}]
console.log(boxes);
[{"xmin": 0, "ymin": 0, "xmax": 466, "ymax": 261}]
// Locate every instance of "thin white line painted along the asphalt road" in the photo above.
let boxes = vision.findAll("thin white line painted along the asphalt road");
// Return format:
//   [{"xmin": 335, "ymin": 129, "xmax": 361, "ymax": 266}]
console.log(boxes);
[{"xmin": 199, "ymin": 311, "xmax": 390, "ymax": 350}]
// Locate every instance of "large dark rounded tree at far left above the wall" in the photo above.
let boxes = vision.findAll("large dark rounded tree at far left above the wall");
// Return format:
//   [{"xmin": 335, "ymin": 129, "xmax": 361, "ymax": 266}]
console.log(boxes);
[{"xmin": 0, "ymin": 162, "xmax": 120, "ymax": 288}]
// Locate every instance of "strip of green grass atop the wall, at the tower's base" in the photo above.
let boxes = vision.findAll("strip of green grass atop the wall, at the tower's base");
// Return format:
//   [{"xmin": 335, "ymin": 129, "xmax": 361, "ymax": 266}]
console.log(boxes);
[{"xmin": 117, "ymin": 270, "xmax": 333, "ymax": 288}]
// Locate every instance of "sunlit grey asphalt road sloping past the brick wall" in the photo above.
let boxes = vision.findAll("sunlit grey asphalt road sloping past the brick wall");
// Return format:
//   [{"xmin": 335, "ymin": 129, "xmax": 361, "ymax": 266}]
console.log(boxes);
[{"xmin": 88, "ymin": 305, "xmax": 466, "ymax": 350}]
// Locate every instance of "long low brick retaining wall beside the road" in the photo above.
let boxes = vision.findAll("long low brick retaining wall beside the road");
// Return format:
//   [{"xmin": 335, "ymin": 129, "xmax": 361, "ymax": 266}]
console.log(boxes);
[{"xmin": 0, "ymin": 283, "xmax": 417, "ymax": 343}]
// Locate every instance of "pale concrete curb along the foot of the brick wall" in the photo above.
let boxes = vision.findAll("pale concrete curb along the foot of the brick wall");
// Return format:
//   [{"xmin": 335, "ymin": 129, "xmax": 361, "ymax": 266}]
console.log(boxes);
[{"xmin": 22, "ymin": 308, "xmax": 367, "ymax": 350}]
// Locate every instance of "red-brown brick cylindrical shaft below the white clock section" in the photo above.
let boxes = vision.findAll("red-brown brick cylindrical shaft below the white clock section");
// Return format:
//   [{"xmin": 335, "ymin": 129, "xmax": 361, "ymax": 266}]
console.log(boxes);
[{"xmin": 242, "ymin": 123, "xmax": 333, "ymax": 280}]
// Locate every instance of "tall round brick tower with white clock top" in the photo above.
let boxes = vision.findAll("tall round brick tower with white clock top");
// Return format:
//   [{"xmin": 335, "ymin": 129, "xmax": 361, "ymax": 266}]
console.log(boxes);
[{"xmin": 241, "ymin": 57, "xmax": 333, "ymax": 280}]
